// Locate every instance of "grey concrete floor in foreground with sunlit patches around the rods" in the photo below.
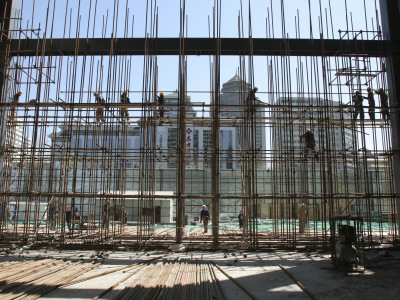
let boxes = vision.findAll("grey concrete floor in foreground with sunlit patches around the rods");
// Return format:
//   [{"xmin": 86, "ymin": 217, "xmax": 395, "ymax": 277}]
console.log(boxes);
[{"xmin": 0, "ymin": 250, "xmax": 400, "ymax": 300}]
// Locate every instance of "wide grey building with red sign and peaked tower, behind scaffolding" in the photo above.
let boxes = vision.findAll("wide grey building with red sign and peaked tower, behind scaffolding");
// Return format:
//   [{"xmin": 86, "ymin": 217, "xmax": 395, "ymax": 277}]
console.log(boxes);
[{"xmin": 49, "ymin": 76, "xmax": 266, "ymax": 170}]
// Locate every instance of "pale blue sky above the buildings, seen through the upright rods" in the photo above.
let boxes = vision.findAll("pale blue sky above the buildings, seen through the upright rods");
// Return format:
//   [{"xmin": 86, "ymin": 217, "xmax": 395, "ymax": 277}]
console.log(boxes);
[{"xmin": 9, "ymin": 0, "xmax": 390, "ymax": 150}]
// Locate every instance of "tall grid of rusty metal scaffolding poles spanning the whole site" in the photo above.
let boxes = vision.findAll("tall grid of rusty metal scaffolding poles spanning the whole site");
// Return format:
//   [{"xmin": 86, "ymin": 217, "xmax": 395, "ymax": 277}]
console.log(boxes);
[{"xmin": 0, "ymin": 0, "xmax": 400, "ymax": 250}]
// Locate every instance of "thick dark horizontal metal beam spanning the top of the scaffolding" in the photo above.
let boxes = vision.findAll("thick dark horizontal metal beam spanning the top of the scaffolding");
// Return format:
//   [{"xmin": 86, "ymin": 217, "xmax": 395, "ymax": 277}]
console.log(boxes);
[{"xmin": 9, "ymin": 38, "xmax": 400, "ymax": 57}]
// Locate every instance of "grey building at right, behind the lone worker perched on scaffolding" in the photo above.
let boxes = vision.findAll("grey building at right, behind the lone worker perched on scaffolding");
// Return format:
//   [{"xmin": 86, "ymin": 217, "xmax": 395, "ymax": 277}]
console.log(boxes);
[{"xmin": 271, "ymin": 97, "xmax": 355, "ymax": 167}]
